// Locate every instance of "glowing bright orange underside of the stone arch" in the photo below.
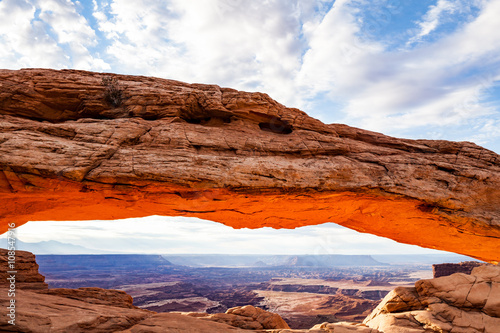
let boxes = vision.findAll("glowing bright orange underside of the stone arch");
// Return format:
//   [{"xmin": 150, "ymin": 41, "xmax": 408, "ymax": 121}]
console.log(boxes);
[{"xmin": 0, "ymin": 175, "xmax": 500, "ymax": 263}]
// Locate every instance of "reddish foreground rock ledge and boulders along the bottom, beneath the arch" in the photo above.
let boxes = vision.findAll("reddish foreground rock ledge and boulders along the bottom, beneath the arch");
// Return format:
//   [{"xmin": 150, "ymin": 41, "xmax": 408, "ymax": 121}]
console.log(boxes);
[{"xmin": 0, "ymin": 249, "xmax": 500, "ymax": 333}]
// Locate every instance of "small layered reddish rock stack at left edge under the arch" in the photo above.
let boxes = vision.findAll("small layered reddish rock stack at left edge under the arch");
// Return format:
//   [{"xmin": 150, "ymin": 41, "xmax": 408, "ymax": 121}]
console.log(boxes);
[{"xmin": 0, "ymin": 249, "xmax": 48, "ymax": 290}]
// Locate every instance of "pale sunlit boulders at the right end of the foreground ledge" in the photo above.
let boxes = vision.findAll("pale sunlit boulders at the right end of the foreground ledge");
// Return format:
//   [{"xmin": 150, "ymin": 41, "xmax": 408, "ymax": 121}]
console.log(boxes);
[{"xmin": 364, "ymin": 266, "xmax": 500, "ymax": 333}]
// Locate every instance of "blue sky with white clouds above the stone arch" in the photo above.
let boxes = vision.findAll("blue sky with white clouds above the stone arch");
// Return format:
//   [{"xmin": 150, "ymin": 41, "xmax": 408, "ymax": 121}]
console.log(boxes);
[{"xmin": 0, "ymin": 0, "xmax": 500, "ymax": 152}]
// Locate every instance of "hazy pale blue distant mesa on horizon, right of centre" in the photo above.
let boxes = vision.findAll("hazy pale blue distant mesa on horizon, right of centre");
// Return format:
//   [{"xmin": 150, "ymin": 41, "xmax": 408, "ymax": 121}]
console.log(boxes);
[{"xmin": 163, "ymin": 254, "xmax": 387, "ymax": 267}]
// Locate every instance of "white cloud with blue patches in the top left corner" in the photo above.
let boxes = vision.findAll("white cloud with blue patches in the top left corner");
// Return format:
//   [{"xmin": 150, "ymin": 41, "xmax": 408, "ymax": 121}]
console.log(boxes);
[{"xmin": 0, "ymin": 0, "xmax": 110, "ymax": 70}]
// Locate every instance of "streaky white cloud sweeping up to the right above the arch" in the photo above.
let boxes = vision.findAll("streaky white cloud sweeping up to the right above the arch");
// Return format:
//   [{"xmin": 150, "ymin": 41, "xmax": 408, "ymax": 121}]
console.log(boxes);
[{"xmin": 301, "ymin": 1, "xmax": 500, "ymax": 137}]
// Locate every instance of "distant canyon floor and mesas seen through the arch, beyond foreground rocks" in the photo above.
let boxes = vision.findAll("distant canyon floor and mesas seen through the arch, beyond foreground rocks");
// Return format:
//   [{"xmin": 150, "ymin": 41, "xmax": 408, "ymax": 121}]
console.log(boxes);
[{"xmin": 33, "ymin": 255, "xmax": 438, "ymax": 328}]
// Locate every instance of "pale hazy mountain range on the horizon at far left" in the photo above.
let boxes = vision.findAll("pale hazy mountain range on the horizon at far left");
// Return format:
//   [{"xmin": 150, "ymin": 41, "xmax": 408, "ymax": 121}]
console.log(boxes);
[{"xmin": 0, "ymin": 239, "xmax": 116, "ymax": 254}]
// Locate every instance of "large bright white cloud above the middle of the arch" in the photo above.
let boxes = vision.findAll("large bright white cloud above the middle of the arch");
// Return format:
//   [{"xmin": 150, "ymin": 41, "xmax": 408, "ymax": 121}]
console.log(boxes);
[{"xmin": 95, "ymin": 0, "xmax": 317, "ymax": 103}]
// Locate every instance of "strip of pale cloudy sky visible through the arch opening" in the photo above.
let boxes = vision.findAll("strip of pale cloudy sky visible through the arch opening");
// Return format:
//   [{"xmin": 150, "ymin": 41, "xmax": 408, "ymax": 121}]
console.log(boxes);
[{"xmin": 0, "ymin": 216, "xmax": 460, "ymax": 255}]
